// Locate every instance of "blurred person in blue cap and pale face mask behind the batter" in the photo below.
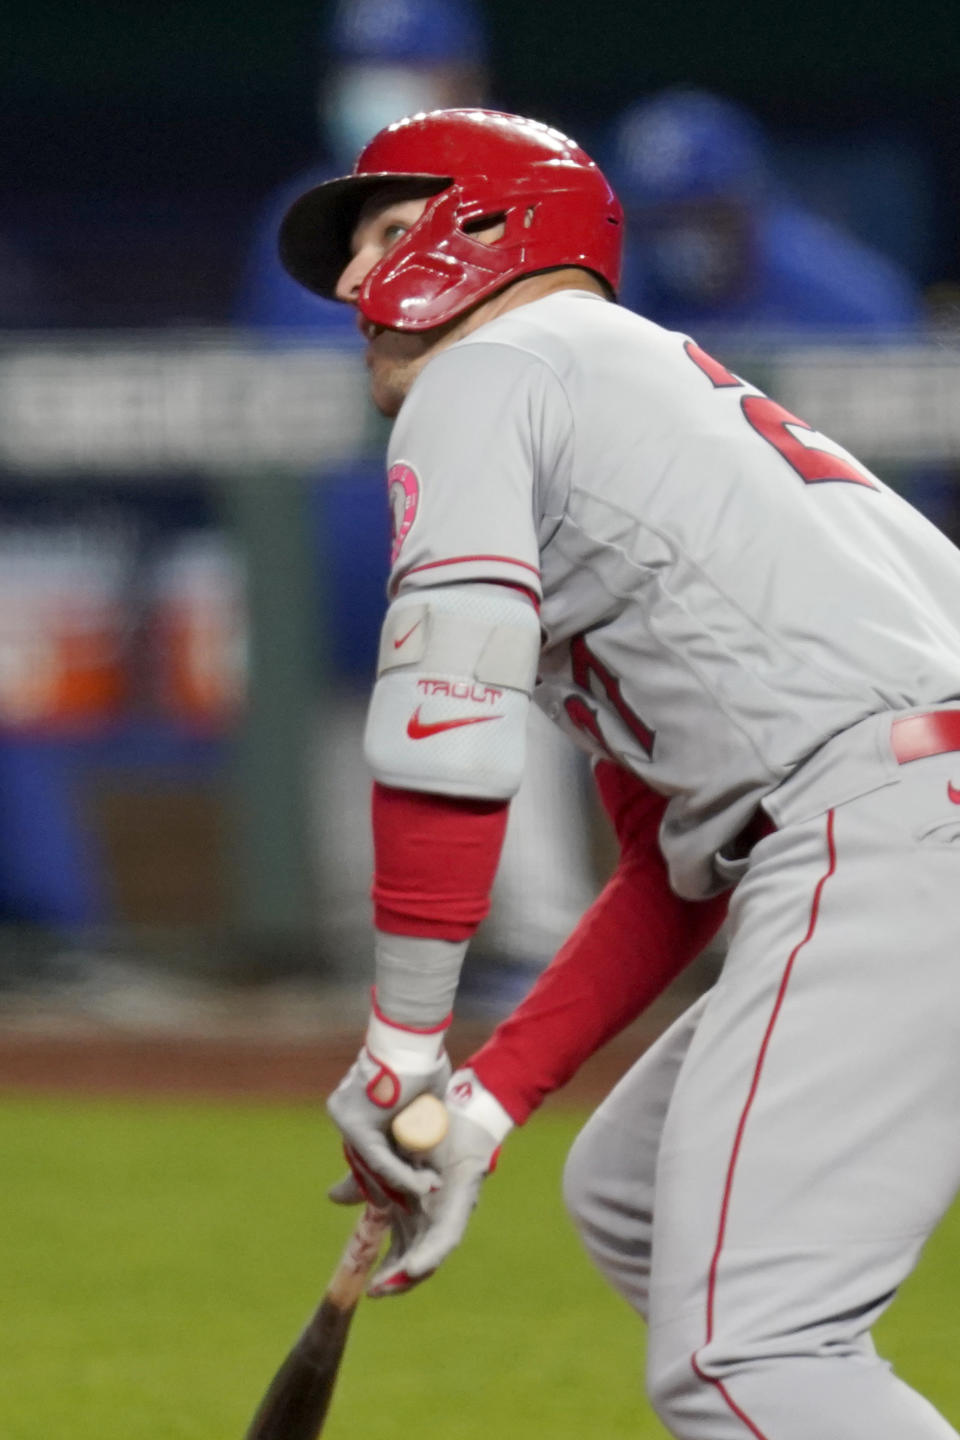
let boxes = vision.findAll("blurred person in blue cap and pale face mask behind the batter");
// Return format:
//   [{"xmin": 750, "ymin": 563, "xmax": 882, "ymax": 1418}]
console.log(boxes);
[{"xmin": 235, "ymin": 0, "xmax": 597, "ymax": 979}]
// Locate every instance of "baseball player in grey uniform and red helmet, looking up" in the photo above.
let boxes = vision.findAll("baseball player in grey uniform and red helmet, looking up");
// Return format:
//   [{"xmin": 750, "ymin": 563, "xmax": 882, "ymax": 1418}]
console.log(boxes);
[{"xmin": 281, "ymin": 111, "xmax": 960, "ymax": 1440}]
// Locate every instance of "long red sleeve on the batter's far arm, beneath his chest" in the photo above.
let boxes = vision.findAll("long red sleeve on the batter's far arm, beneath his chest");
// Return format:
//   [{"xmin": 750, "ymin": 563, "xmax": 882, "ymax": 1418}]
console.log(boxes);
[{"xmin": 468, "ymin": 760, "xmax": 727, "ymax": 1125}]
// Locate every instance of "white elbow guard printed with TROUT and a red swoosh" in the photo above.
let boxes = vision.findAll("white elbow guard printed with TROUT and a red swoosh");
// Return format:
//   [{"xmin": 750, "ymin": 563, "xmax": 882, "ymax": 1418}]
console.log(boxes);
[{"xmin": 364, "ymin": 585, "xmax": 540, "ymax": 799}]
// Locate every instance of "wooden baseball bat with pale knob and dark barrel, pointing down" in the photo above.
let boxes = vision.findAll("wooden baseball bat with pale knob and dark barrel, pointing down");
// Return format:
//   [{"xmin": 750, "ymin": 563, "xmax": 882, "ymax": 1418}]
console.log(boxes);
[{"xmin": 246, "ymin": 1094, "xmax": 448, "ymax": 1440}]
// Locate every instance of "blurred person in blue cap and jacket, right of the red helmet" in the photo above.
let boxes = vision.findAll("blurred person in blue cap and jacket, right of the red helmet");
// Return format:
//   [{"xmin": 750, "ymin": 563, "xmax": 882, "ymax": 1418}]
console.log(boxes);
[{"xmin": 607, "ymin": 86, "xmax": 921, "ymax": 336}]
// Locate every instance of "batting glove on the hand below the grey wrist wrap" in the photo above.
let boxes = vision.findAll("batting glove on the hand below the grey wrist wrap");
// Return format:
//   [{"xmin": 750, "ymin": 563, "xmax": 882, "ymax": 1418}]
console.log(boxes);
[{"xmin": 327, "ymin": 1005, "xmax": 450, "ymax": 1208}]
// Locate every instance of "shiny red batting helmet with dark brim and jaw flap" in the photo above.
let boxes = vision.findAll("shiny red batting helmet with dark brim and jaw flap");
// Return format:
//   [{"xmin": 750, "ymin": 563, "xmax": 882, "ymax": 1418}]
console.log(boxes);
[{"xmin": 279, "ymin": 109, "xmax": 623, "ymax": 330}]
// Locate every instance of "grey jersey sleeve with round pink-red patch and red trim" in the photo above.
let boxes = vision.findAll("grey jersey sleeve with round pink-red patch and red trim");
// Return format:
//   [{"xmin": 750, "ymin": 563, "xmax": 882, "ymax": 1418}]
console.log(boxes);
[{"xmin": 387, "ymin": 341, "xmax": 570, "ymax": 600}]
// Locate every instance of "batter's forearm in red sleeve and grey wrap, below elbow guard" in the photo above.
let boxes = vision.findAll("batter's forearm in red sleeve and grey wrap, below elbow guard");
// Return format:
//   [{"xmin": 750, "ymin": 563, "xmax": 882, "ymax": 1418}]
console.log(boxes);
[{"xmin": 373, "ymin": 783, "xmax": 508, "ymax": 1027}]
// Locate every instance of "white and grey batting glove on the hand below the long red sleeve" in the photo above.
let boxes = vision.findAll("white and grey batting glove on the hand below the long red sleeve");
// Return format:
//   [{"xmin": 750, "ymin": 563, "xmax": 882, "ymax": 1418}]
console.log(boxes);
[{"xmin": 367, "ymin": 1070, "xmax": 514, "ymax": 1296}]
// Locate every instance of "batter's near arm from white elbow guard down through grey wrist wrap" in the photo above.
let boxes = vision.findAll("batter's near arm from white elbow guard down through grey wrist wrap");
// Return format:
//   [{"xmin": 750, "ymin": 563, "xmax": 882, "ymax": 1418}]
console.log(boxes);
[{"xmin": 364, "ymin": 583, "xmax": 540, "ymax": 1027}]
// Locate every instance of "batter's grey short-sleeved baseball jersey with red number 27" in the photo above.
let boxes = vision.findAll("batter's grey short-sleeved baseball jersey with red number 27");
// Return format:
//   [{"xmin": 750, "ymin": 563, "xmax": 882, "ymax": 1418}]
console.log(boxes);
[{"xmin": 389, "ymin": 291, "xmax": 960, "ymax": 897}]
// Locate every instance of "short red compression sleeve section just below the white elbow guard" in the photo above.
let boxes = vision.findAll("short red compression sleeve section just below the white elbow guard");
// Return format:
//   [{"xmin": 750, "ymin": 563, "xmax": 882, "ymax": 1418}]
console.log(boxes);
[{"xmin": 373, "ymin": 780, "xmax": 508, "ymax": 940}]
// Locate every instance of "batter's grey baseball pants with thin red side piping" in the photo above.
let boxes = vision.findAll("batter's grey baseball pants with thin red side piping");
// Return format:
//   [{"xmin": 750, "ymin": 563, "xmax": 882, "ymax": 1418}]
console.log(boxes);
[{"xmin": 564, "ymin": 752, "xmax": 960, "ymax": 1440}]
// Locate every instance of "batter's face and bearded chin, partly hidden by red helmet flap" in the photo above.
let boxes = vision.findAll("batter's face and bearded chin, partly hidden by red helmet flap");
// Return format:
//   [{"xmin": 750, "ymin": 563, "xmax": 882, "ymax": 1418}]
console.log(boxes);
[{"xmin": 337, "ymin": 197, "xmax": 439, "ymax": 416}]
